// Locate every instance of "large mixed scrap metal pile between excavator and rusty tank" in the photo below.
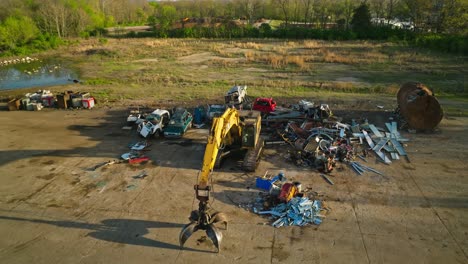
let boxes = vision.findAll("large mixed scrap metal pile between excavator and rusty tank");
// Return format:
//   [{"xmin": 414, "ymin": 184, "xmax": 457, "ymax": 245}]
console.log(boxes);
[{"xmin": 270, "ymin": 101, "xmax": 409, "ymax": 172}]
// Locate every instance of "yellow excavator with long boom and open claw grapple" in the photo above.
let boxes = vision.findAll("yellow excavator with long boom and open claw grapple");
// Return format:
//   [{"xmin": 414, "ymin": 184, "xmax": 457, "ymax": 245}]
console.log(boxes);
[{"xmin": 179, "ymin": 108, "xmax": 264, "ymax": 252}]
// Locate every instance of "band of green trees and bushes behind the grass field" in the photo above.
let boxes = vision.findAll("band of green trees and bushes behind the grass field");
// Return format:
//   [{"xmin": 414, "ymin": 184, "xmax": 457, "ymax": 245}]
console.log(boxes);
[{"xmin": 0, "ymin": 0, "xmax": 468, "ymax": 55}]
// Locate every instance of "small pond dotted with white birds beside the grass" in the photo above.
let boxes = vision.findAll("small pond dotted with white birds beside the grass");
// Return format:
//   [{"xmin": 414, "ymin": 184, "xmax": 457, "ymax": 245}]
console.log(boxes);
[{"xmin": 0, "ymin": 60, "xmax": 78, "ymax": 90}]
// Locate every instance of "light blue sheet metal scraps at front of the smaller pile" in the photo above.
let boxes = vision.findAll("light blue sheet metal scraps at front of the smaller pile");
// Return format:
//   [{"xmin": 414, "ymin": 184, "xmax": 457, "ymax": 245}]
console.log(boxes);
[{"xmin": 258, "ymin": 197, "xmax": 323, "ymax": 227}]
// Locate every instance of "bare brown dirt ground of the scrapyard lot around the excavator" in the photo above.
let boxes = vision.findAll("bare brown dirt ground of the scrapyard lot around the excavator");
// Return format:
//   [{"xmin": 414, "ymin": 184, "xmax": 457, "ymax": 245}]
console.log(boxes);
[{"xmin": 0, "ymin": 102, "xmax": 468, "ymax": 264}]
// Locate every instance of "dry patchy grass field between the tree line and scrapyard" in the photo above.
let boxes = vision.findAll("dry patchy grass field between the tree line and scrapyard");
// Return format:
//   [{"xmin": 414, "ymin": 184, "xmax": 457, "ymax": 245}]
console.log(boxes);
[{"xmin": 0, "ymin": 38, "xmax": 468, "ymax": 114}]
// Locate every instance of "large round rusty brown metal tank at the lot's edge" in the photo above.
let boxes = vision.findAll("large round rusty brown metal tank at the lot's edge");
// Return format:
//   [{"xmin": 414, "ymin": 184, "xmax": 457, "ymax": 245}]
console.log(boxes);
[{"xmin": 397, "ymin": 82, "xmax": 444, "ymax": 130}]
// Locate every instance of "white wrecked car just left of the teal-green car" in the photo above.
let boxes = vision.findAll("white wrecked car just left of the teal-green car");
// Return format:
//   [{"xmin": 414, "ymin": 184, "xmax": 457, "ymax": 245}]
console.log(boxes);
[{"xmin": 137, "ymin": 109, "xmax": 171, "ymax": 138}]
